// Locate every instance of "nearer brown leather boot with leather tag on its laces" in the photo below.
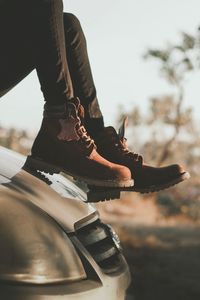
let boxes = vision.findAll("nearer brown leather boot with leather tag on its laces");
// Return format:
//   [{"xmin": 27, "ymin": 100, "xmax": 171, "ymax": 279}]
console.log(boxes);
[{"xmin": 28, "ymin": 99, "xmax": 133, "ymax": 187}]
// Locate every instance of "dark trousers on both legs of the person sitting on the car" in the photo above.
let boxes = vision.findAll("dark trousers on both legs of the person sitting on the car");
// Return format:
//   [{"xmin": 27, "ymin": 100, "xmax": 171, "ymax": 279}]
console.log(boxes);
[{"xmin": 0, "ymin": 0, "xmax": 103, "ymax": 131}]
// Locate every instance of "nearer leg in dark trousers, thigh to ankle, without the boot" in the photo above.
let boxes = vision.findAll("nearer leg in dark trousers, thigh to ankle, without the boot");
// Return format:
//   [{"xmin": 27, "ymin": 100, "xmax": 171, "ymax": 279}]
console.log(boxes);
[{"xmin": 0, "ymin": 0, "xmax": 73, "ymax": 105}]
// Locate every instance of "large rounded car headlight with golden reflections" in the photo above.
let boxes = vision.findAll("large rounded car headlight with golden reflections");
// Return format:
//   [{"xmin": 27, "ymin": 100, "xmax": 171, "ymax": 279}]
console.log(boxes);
[{"xmin": 0, "ymin": 190, "xmax": 86, "ymax": 284}]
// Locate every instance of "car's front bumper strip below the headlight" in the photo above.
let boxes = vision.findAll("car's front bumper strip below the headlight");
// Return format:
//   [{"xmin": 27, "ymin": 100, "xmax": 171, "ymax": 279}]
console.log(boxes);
[{"xmin": 0, "ymin": 273, "xmax": 129, "ymax": 300}]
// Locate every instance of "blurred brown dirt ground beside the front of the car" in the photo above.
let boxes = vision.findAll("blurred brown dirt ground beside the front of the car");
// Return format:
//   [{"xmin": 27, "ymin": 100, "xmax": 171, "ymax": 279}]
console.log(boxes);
[{"xmin": 99, "ymin": 198, "xmax": 200, "ymax": 300}]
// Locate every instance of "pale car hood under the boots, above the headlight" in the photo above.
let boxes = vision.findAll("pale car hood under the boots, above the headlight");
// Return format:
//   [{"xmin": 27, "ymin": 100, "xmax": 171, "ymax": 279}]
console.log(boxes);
[{"xmin": 0, "ymin": 147, "xmax": 97, "ymax": 232}]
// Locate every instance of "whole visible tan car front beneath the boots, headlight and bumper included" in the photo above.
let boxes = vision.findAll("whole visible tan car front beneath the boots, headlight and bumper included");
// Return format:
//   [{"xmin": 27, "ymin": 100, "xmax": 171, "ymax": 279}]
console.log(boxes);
[{"xmin": 0, "ymin": 147, "xmax": 130, "ymax": 300}]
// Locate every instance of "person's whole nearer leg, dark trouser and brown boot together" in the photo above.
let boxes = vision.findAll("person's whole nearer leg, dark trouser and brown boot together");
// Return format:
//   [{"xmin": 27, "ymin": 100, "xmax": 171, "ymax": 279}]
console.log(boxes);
[{"xmin": 0, "ymin": 0, "xmax": 133, "ymax": 187}]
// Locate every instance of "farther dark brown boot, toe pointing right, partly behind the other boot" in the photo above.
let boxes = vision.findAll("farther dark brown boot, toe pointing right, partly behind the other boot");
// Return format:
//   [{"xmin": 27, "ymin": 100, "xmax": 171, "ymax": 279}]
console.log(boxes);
[{"xmin": 95, "ymin": 117, "xmax": 190, "ymax": 193}]
